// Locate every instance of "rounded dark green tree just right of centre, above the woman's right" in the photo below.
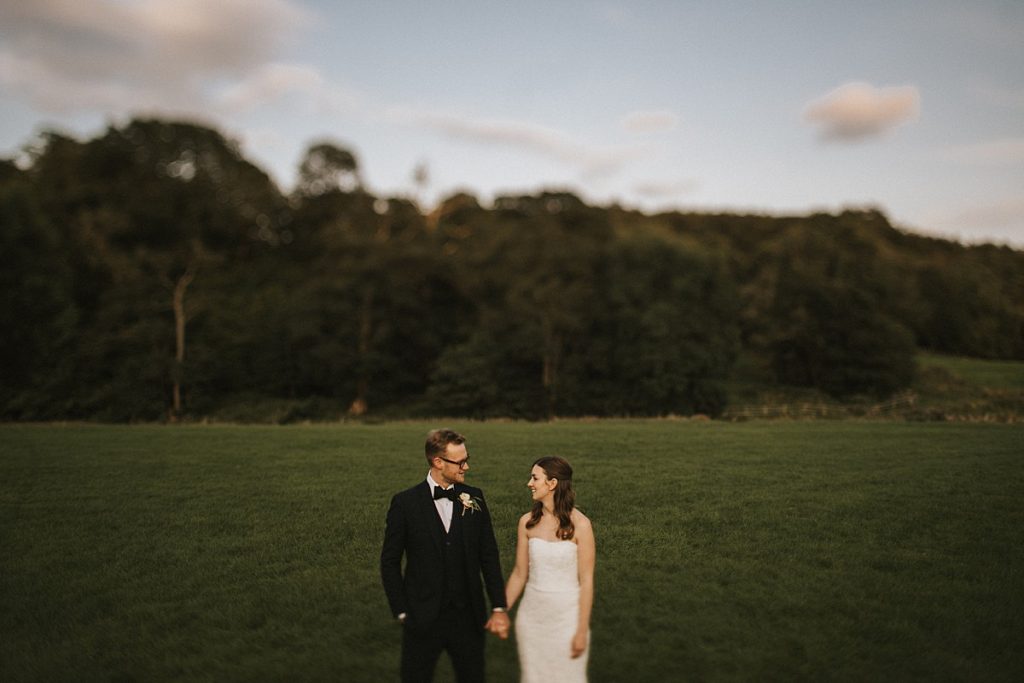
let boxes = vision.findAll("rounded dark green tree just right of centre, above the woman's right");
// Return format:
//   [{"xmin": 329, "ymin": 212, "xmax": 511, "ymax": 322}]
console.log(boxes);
[{"xmin": 566, "ymin": 233, "xmax": 738, "ymax": 415}]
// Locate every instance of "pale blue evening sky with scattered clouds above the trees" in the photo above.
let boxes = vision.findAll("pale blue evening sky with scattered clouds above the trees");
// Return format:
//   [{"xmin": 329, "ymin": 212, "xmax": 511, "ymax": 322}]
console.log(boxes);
[{"xmin": 0, "ymin": 0, "xmax": 1024, "ymax": 248}]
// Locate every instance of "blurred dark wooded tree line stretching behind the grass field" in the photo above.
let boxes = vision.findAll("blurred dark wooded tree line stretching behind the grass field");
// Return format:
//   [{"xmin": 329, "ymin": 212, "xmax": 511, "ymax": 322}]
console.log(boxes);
[{"xmin": 0, "ymin": 119, "xmax": 1024, "ymax": 421}]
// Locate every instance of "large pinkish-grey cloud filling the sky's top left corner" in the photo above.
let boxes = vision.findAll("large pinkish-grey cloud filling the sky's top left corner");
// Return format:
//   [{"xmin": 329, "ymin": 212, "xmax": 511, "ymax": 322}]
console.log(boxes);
[{"xmin": 0, "ymin": 0, "xmax": 308, "ymax": 112}]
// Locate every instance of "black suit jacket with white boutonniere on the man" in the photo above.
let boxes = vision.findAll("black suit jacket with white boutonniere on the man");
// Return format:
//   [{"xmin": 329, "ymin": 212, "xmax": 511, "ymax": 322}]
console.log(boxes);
[{"xmin": 381, "ymin": 480, "xmax": 506, "ymax": 626}]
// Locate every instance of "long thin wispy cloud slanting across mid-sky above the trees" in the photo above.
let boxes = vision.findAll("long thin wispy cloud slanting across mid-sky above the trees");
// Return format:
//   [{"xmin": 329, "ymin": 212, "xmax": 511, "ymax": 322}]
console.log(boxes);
[{"xmin": 389, "ymin": 109, "xmax": 645, "ymax": 177}]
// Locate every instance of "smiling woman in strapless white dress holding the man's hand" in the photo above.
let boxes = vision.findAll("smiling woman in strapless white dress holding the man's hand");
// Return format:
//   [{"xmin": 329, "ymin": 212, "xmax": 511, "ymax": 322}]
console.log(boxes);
[{"xmin": 505, "ymin": 457, "xmax": 595, "ymax": 683}]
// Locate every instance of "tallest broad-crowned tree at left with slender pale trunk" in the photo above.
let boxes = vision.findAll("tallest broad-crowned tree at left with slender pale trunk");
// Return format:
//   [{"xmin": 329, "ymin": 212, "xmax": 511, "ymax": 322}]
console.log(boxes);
[{"xmin": 30, "ymin": 120, "xmax": 283, "ymax": 420}]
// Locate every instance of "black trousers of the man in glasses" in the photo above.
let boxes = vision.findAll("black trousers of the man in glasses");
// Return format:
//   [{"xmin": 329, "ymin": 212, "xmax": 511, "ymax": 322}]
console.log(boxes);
[{"xmin": 401, "ymin": 606, "xmax": 485, "ymax": 683}]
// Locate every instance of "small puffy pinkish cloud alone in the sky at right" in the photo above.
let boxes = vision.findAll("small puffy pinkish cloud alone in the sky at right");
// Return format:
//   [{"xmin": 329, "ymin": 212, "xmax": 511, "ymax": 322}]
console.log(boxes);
[{"xmin": 804, "ymin": 83, "xmax": 921, "ymax": 142}]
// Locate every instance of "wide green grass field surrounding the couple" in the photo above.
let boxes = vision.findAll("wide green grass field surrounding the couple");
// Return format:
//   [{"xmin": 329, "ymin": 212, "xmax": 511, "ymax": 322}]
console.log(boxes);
[{"xmin": 0, "ymin": 421, "xmax": 1024, "ymax": 683}]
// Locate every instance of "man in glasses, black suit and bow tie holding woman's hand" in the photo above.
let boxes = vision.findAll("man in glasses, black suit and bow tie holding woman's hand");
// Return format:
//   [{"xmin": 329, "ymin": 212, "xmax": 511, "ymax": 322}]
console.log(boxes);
[{"xmin": 381, "ymin": 429, "xmax": 509, "ymax": 683}]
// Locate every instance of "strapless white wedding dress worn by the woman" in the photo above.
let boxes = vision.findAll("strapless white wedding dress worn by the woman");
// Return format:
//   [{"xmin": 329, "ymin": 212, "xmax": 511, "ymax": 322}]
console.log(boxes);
[{"xmin": 515, "ymin": 538, "xmax": 590, "ymax": 683}]
